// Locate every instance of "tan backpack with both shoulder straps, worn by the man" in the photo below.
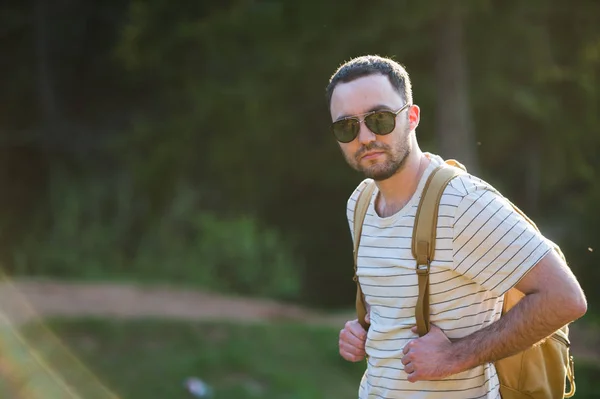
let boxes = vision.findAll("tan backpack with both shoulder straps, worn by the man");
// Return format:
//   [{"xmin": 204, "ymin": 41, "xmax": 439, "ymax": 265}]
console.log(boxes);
[{"xmin": 353, "ymin": 160, "xmax": 575, "ymax": 399}]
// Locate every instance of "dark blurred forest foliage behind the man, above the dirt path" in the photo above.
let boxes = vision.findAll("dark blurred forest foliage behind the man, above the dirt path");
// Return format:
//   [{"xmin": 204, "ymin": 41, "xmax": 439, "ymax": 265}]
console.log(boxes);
[{"xmin": 0, "ymin": 0, "xmax": 600, "ymax": 306}]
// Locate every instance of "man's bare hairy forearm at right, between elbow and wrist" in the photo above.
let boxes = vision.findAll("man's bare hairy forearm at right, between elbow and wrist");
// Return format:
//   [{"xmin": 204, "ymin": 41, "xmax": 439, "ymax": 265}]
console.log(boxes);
[{"xmin": 449, "ymin": 292, "xmax": 572, "ymax": 372}]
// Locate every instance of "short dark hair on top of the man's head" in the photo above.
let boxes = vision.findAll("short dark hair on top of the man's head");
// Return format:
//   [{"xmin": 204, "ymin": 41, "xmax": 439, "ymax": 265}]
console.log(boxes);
[{"xmin": 326, "ymin": 55, "xmax": 412, "ymax": 107}]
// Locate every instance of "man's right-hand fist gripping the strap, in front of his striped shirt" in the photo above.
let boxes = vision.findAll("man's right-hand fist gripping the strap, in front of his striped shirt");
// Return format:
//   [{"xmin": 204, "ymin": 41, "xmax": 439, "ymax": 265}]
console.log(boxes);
[{"xmin": 402, "ymin": 324, "xmax": 459, "ymax": 382}]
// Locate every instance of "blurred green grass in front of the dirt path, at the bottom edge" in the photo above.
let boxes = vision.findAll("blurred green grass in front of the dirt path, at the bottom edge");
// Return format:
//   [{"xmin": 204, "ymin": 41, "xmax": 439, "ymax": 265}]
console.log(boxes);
[{"xmin": 2, "ymin": 319, "xmax": 600, "ymax": 399}]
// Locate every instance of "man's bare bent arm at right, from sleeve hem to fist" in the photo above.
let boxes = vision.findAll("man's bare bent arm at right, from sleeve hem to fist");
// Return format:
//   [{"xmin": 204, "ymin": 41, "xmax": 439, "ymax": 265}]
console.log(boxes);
[{"xmin": 402, "ymin": 245, "xmax": 587, "ymax": 382}]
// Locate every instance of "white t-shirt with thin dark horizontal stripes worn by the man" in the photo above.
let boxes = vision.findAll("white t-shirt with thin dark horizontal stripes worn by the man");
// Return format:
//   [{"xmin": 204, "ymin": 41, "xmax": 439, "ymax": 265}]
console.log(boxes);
[{"xmin": 347, "ymin": 153, "xmax": 552, "ymax": 399}]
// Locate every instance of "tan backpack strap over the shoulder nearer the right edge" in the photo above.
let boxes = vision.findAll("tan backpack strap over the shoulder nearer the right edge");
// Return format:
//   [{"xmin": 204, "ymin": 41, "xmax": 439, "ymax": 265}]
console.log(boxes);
[{"xmin": 412, "ymin": 162, "xmax": 465, "ymax": 336}]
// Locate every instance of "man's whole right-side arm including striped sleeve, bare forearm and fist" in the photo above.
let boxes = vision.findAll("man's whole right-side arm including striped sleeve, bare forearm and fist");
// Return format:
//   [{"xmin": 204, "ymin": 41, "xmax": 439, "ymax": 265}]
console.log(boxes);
[{"xmin": 402, "ymin": 192, "xmax": 587, "ymax": 381}]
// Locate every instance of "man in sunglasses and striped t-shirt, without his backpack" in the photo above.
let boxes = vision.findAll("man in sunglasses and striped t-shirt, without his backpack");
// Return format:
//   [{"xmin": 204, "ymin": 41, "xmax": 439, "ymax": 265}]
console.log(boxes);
[{"xmin": 327, "ymin": 56, "xmax": 587, "ymax": 399}]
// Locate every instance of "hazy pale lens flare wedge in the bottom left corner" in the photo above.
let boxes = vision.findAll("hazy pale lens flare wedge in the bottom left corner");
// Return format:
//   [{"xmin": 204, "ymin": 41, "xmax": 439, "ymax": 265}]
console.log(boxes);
[{"xmin": 0, "ymin": 275, "xmax": 119, "ymax": 399}]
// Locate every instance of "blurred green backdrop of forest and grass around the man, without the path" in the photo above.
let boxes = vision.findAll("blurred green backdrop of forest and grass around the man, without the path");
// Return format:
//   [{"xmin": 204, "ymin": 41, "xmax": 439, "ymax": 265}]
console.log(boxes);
[{"xmin": 0, "ymin": 0, "xmax": 600, "ymax": 398}]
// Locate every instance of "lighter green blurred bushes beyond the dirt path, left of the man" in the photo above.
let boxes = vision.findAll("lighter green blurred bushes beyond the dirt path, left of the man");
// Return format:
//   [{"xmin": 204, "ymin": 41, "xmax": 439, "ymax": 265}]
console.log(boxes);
[{"xmin": 13, "ymin": 173, "xmax": 303, "ymax": 299}]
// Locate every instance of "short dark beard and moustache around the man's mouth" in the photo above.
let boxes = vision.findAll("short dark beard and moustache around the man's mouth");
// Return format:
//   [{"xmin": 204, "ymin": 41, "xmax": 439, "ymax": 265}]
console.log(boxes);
[{"xmin": 345, "ymin": 135, "xmax": 410, "ymax": 181}]
